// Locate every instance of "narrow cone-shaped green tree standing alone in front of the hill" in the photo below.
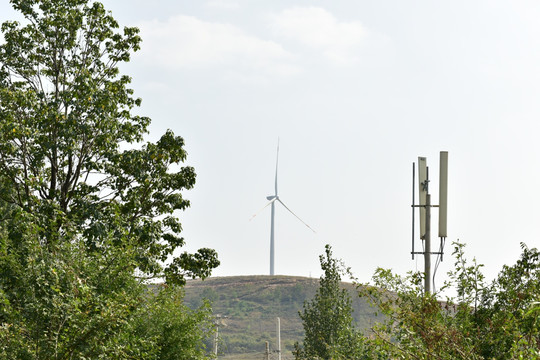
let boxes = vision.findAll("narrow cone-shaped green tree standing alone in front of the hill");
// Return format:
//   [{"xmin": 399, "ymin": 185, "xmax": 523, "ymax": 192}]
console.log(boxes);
[{"xmin": 295, "ymin": 245, "xmax": 367, "ymax": 359}]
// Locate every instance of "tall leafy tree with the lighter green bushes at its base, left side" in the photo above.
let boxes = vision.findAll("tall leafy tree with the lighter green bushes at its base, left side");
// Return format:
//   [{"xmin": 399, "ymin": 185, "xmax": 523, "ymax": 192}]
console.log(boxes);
[{"xmin": 0, "ymin": 0, "xmax": 219, "ymax": 359}]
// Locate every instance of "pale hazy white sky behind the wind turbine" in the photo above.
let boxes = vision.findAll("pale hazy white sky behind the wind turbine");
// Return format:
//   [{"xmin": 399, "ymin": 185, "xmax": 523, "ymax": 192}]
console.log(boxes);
[{"xmin": 0, "ymin": 0, "xmax": 540, "ymax": 284}]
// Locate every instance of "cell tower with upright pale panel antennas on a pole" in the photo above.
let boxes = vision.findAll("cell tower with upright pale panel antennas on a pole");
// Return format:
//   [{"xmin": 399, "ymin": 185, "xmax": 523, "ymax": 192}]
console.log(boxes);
[{"xmin": 411, "ymin": 151, "xmax": 448, "ymax": 294}]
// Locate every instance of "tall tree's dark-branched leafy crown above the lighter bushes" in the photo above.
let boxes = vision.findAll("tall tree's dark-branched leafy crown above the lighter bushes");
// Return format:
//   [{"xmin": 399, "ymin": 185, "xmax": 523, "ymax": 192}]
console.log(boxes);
[{"xmin": 0, "ymin": 0, "xmax": 217, "ymax": 283}]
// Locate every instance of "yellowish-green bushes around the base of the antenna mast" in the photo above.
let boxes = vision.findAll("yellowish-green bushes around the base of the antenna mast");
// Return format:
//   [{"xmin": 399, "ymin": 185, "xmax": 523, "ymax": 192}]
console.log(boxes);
[{"xmin": 359, "ymin": 243, "xmax": 540, "ymax": 359}]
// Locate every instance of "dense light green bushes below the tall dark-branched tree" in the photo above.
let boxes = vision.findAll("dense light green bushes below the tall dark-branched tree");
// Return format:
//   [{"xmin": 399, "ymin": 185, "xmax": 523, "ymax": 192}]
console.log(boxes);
[{"xmin": 0, "ymin": 217, "xmax": 151, "ymax": 359}]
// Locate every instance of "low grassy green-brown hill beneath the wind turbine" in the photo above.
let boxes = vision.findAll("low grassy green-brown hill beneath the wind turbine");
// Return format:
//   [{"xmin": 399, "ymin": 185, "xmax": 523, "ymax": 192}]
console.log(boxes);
[{"xmin": 185, "ymin": 275, "xmax": 375, "ymax": 360}]
